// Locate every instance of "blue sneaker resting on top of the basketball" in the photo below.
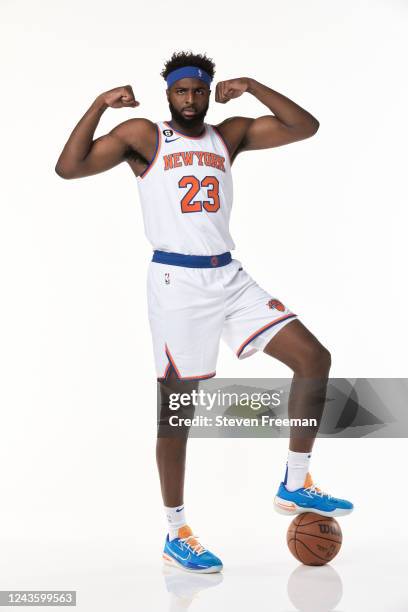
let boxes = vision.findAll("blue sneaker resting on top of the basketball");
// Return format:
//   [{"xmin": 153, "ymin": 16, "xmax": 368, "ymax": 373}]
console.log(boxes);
[{"xmin": 274, "ymin": 474, "xmax": 354, "ymax": 516}]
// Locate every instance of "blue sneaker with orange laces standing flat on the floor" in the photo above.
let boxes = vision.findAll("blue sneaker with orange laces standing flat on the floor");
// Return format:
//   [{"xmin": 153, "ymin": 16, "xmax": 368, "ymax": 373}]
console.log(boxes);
[{"xmin": 163, "ymin": 525, "xmax": 222, "ymax": 574}]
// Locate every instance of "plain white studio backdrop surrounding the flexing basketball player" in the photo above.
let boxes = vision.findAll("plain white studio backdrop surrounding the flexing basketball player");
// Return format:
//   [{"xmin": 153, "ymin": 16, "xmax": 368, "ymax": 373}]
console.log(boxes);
[{"xmin": 0, "ymin": 0, "xmax": 408, "ymax": 612}]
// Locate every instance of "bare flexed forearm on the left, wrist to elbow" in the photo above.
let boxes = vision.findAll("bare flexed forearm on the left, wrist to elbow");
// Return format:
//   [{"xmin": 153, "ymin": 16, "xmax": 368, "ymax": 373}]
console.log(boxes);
[{"xmin": 55, "ymin": 97, "xmax": 108, "ymax": 173}]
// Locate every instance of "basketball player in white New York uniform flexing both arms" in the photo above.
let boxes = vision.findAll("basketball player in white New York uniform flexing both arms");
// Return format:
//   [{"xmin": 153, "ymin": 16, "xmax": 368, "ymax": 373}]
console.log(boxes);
[{"xmin": 56, "ymin": 52, "xmax": 353, "ymax": 573}]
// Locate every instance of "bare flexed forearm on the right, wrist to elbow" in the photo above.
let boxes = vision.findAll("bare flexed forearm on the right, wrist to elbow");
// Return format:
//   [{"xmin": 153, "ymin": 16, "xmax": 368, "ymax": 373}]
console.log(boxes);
[{"xmin": 247, "ymin": 78, "xmax": 319, "ymax": 129}]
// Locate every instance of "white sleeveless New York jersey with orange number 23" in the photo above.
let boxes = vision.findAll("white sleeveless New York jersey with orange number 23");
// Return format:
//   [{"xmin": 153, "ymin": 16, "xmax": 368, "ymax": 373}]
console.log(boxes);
[{"xmin": 137, "ymin": 121, "xmax": 235, "ymax": 255}]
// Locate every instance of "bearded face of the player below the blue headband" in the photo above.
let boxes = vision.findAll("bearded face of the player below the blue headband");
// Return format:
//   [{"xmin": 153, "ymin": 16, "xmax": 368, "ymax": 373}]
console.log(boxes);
[{"xmin": 167, "ymin": 78, "xmax": 210, "ymax": 128}]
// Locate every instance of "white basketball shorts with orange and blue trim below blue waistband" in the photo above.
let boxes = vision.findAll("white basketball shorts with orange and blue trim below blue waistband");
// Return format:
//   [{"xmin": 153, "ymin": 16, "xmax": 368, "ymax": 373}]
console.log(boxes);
[{"xmin": 147, "ymin": 252, "xmax": 297, "ymax": 380}]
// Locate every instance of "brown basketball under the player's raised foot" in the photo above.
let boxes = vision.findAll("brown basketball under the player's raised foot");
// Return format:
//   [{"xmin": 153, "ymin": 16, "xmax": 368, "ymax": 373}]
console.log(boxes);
[{"xmin": 287, "ymin": 512, "xmax": 343, "ymax": 565}]
